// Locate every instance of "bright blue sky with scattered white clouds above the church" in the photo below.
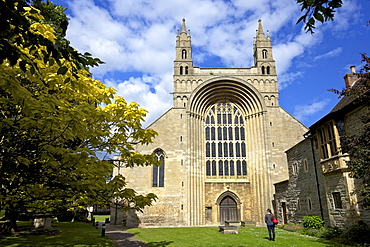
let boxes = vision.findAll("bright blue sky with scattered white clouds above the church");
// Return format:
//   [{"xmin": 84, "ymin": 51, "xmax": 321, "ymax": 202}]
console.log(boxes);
[{"xmin": 53, "ymin": 0, "xmax": 370, "ymax": 126}]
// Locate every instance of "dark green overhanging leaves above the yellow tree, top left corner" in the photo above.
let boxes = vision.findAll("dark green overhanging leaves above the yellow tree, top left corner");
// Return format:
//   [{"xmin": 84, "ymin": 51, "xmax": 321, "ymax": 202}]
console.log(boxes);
[{"xmin": 0, "ymin": 0, "xmax": 102, "ymax": 78}]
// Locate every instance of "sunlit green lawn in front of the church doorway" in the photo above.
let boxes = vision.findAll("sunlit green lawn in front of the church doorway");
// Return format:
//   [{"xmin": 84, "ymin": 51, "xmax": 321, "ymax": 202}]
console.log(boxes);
[{"xmin": 128, "ymin": 227, "xmax": 341, "ymax": 247}]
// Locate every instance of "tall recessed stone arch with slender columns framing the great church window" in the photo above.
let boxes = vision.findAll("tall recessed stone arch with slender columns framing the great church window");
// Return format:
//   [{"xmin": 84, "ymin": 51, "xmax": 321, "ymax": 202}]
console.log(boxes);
[{"xmin": 187, "ymin": 77, "xmax": 268, "ymax": 225}]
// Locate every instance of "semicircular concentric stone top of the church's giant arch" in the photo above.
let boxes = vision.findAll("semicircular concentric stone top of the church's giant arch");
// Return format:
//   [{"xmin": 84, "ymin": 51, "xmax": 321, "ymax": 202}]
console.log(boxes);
[{"xmin": 188, "ymin": 77, "xmax": 266, "ymax": 117}]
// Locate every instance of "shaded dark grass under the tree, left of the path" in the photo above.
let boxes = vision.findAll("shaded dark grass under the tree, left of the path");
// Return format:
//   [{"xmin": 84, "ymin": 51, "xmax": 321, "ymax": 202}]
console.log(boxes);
[{"xmin": 0, "ymin": 221, "xmax": 114, "ymax": 247}]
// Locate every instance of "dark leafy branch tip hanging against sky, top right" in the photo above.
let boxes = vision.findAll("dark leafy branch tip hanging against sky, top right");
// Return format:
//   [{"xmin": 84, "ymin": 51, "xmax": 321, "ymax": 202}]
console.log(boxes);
[{"xmin": 297, "ymin": 0, "xmax": 343, "ymax": 33}]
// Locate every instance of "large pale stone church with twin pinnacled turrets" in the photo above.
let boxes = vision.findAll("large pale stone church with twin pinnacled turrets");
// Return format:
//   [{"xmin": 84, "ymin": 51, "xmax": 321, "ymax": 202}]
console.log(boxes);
[{"xmin": 111, "ymin": 19, "xmax": 307, "ymax": 226}]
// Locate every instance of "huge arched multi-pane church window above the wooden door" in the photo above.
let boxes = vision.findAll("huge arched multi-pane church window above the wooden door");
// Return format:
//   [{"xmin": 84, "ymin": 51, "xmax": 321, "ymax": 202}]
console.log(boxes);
[{"xmin": 205, "ymin": 102, "xmax": 247, "ymax": 179}]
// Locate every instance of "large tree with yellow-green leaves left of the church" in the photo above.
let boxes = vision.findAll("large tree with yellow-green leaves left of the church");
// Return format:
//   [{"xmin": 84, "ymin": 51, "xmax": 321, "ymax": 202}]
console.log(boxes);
[{"xmin": 0, "ymin": 0, "xmax": 156, "ymax": 227}]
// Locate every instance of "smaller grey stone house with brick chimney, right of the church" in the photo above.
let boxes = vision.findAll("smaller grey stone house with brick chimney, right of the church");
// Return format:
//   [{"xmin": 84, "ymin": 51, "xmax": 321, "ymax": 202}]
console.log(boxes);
[{"xmin": 275, "ymin": 67, "xmax": 370, "ymax": 228}]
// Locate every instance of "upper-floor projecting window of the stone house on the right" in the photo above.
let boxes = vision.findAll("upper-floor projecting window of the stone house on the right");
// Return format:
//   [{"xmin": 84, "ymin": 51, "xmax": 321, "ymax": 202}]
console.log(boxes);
[{"xmin": 317, "ymin": 122, "xmax": 339, "ymax": 159}]
